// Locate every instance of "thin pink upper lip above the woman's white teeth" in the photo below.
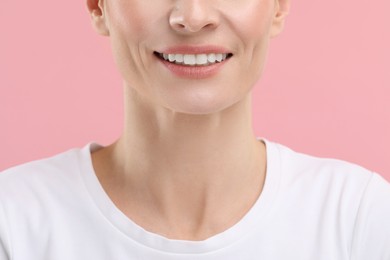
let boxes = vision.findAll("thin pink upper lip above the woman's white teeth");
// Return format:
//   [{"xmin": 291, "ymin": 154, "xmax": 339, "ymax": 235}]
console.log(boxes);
[{"xmin": 157, "ymin": 45, "xmax": 232, "ymax": 54}]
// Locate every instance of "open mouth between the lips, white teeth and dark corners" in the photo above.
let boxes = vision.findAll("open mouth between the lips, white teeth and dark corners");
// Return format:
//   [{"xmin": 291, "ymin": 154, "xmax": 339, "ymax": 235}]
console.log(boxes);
[{"xmin": 153, "ymin": 51, "xmax": 233, "ymax": 67}]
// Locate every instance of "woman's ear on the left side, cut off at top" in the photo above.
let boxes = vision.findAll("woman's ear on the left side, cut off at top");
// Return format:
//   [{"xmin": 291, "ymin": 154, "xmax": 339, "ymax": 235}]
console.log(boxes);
[{"xmin": 87, "ymin": 0, "xmax": 110, "ymax": 36}]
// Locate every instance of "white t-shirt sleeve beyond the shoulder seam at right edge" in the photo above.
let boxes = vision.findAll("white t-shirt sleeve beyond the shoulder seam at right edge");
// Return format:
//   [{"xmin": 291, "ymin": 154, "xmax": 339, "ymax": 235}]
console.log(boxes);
[{"xmin": 351, "ymin": 173, "xmax": 390, "ymax": 260}]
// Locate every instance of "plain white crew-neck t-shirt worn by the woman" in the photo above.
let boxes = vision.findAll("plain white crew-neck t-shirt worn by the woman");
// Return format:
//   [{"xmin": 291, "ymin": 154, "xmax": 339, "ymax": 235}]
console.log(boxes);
[{"xmin": 0, "ymin": 140, "xmax": 390, "ymax": 260}]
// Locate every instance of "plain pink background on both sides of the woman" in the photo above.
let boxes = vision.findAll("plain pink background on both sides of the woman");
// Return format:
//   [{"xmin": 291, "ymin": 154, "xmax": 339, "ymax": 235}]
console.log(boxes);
[{"xmin": 0, "ymin": 0, "xmax": 390, "ymax": 180}]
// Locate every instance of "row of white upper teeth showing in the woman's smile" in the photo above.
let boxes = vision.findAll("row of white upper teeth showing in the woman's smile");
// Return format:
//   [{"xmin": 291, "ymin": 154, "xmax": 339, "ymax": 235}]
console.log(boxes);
[{"xmin": 160, "ymin": 53, "xmax": 228, "ymax": 66}]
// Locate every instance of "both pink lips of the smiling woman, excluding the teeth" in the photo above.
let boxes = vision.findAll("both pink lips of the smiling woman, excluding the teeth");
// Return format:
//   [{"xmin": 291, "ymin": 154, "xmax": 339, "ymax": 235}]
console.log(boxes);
[{"xmin": 155, "ymin": 45, "xmax": 233, "ymax": 79}]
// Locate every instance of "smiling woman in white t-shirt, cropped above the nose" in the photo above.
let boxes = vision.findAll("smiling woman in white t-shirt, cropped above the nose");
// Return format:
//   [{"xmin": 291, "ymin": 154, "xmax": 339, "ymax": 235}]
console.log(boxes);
[{"xmin": 0, "ymin": 0, "xmax": 390, "ymax": 260}]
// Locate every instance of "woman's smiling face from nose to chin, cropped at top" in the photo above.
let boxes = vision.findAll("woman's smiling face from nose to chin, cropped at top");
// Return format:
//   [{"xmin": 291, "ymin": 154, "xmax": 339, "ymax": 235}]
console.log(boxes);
[{"xmin": 93, "ymin": 0, "xmax": 279, "ymax": 114}]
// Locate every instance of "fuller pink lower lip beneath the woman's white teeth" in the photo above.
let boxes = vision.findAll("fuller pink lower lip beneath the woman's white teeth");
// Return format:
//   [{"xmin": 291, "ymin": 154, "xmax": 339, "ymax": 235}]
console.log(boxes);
[{"xmin": 156, "ymin": 57, "xmax": 230, "ymax": 79}]
